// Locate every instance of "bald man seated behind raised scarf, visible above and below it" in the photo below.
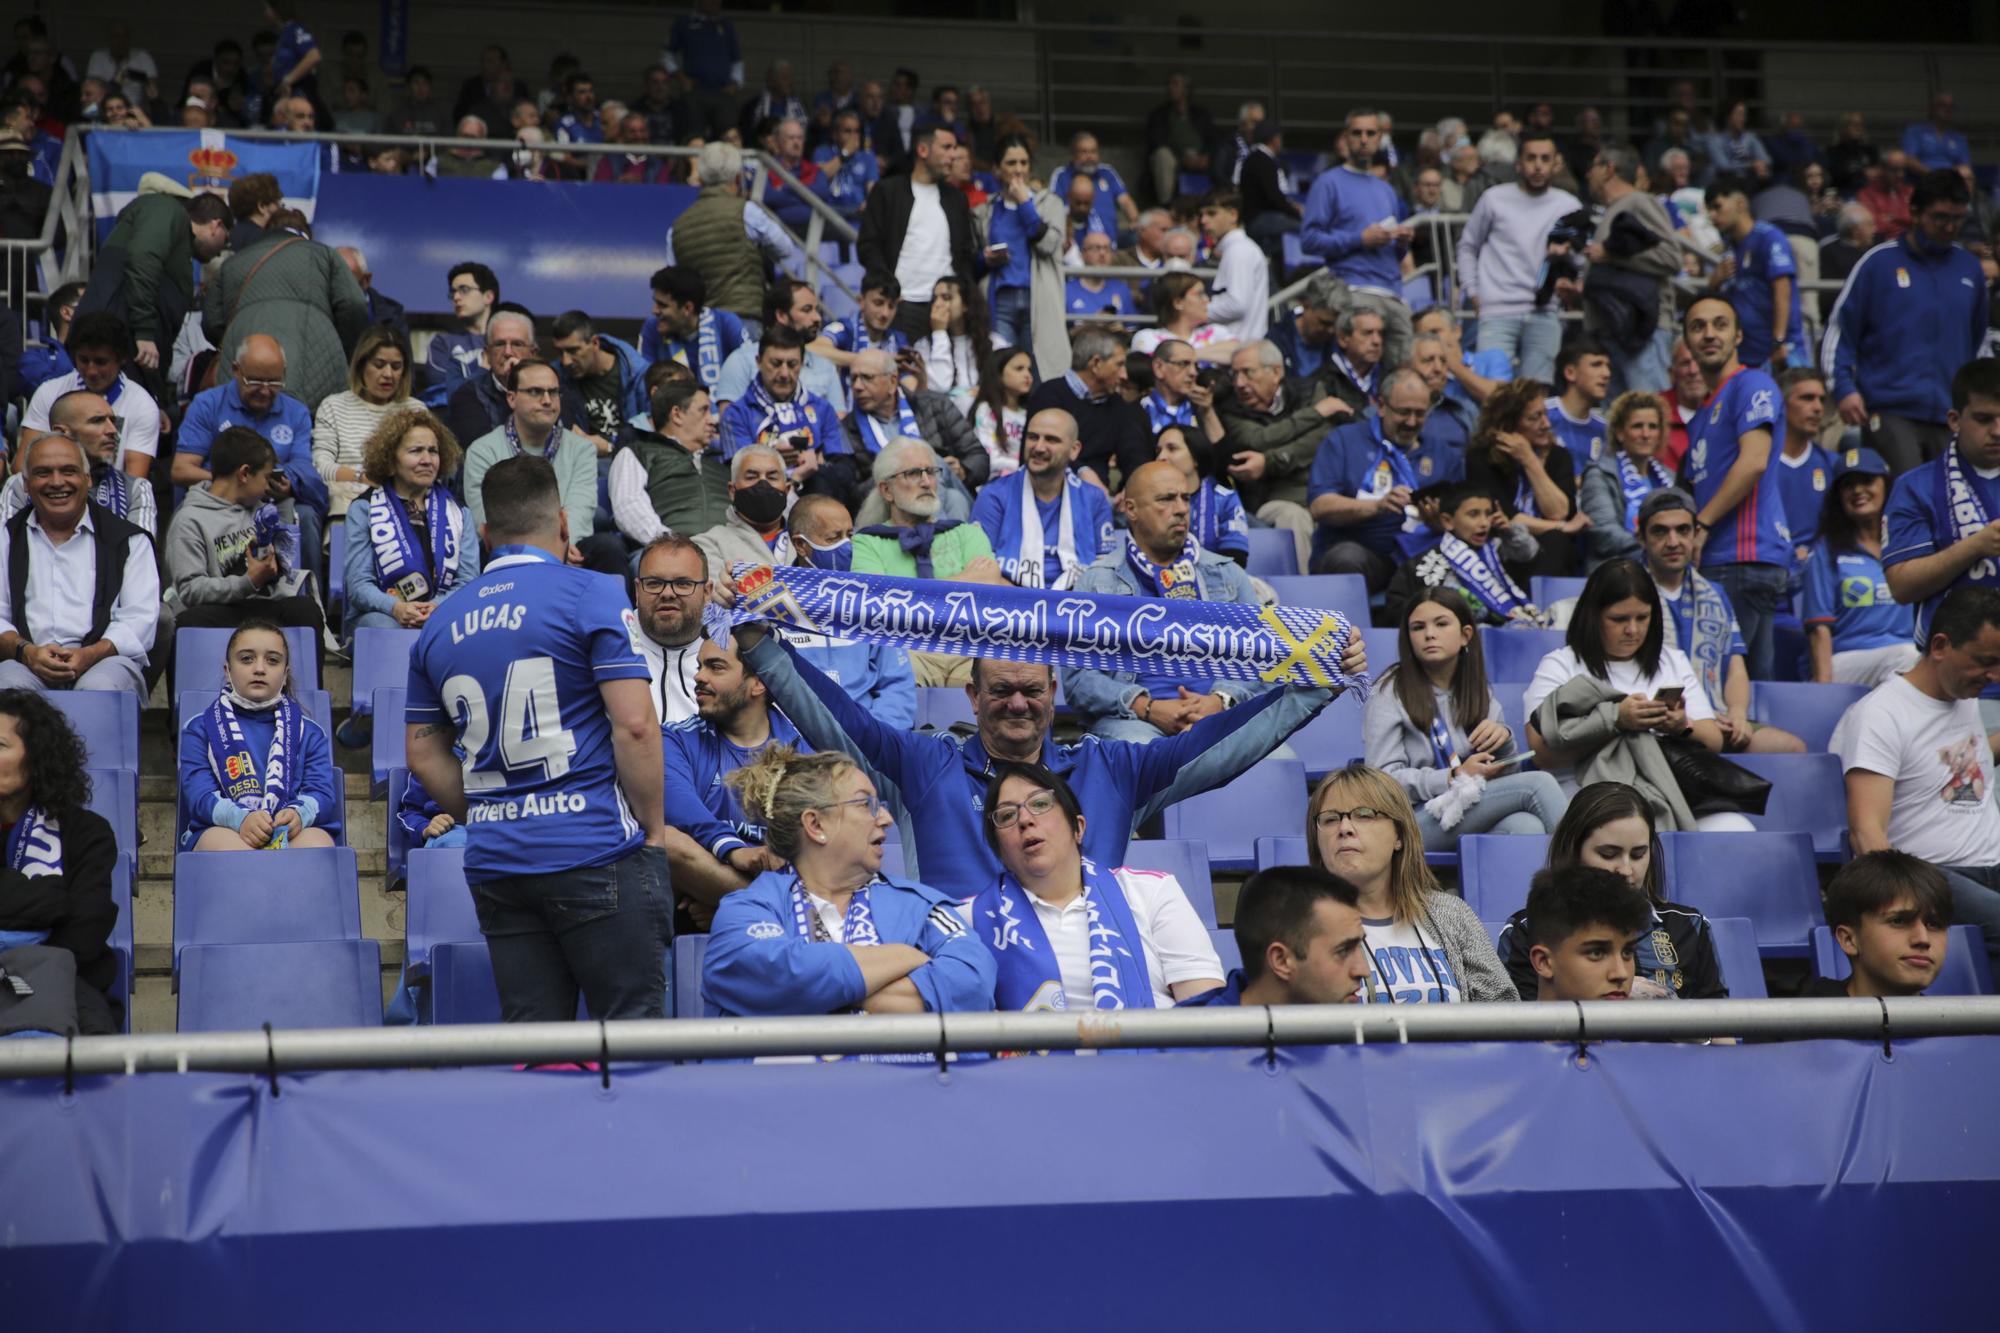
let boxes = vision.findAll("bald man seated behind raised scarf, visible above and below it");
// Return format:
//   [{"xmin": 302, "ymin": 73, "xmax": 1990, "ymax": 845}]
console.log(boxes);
[{"xmin": 1062, "ymin": 462, "xmax": 1270, "ymax": 745}]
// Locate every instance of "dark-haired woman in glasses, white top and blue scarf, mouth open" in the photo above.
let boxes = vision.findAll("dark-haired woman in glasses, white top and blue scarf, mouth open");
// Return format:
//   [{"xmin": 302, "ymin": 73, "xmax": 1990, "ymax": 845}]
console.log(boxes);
[{"xmin": 972, "ymin": 763, "xmax": 1222, "ymax": 1011}]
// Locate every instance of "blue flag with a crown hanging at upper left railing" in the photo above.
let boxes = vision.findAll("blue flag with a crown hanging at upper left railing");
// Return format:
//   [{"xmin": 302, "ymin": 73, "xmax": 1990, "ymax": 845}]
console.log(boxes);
[{"xmin": 84, "ymin": 130, "xmax": 320, "ymax": 240}]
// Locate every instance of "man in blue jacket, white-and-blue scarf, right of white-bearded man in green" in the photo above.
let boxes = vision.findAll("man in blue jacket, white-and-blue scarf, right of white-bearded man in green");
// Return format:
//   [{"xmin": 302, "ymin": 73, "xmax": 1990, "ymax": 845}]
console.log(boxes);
[{"xmin": 972, "ymin": 408, "xmax": 1140, "ymax": 588}]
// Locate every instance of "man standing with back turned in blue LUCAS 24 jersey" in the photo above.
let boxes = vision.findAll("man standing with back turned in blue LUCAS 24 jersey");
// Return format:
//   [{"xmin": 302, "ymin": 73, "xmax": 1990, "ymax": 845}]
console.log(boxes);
[{"xmin": 404, "ymin": 456, "xmax": 672, "ymax": 1023}]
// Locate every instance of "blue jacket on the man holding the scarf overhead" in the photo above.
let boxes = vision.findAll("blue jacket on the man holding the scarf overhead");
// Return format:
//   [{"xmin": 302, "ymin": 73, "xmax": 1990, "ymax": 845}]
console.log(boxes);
[{"xmin": 748, "ymin": 638, "xmax": 1332, "ymax": 899}]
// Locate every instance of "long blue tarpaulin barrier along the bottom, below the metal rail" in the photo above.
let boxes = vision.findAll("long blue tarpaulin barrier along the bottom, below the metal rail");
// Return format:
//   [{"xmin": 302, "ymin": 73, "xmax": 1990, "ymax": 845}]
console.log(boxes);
[{"xmin": 0, "ymin": 1037, "xmax": 2000, "ymax": 1333}]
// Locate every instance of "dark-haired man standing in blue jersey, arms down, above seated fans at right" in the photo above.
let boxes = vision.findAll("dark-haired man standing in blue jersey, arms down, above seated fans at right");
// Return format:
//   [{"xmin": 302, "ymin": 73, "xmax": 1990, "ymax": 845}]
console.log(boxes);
[{"xmin": 1682, "ymin": 296, "xmax": 1792, "ymax": 681}]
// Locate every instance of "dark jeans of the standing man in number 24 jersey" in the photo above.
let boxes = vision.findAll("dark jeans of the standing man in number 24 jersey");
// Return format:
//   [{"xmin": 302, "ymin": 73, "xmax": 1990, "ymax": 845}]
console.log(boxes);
[{"xmin": 472, "ymin": 847, "xmax": 674, "ymax": 1023}]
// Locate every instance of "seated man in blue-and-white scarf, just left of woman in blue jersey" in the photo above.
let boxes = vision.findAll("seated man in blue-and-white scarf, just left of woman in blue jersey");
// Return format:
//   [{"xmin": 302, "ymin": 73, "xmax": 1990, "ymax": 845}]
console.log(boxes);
[{"xmin": 1638, "ymin": 488, "xmax": 1806, "ymax": 755}]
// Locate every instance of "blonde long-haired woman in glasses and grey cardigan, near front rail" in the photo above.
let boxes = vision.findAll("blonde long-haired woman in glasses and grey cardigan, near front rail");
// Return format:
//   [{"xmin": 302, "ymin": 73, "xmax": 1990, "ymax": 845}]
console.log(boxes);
[{"xmin": 1306, "ymin": 765, "xmax": 1520, "ymax": 1005}]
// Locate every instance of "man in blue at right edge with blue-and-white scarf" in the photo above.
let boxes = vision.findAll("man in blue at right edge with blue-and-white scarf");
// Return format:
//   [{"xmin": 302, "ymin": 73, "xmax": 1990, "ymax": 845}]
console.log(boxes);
[{"xmin": 1882, "ymin": 358, "xmax": 2000, "ymax": 729}]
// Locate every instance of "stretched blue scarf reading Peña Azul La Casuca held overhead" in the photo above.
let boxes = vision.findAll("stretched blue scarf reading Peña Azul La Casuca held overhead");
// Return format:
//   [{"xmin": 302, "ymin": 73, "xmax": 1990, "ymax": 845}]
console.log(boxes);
[{"xmin": 728, "ymin": 564, "xmax": 1368, "ymax": 693}]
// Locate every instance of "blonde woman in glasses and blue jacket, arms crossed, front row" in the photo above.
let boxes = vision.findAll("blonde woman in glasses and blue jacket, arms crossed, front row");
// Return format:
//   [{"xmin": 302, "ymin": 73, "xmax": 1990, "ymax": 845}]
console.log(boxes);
[{"xmin": 702, "ymin": 745, "xmax": 994, "ymax": 1017}]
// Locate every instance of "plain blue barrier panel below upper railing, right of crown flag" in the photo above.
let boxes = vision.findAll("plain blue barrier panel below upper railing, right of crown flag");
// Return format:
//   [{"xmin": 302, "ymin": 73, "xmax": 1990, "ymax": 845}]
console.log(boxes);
[{"xmin": 304, "ymin": 174, "xmax": 696, "ymax": 320}]
